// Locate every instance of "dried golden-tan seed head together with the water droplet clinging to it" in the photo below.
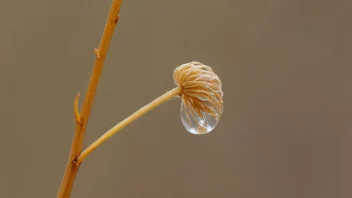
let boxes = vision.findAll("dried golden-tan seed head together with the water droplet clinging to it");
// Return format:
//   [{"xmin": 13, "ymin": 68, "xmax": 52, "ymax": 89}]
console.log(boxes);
[{"xmin": 174, "ymin": 61, "xmax": 223, "ymax": 134}]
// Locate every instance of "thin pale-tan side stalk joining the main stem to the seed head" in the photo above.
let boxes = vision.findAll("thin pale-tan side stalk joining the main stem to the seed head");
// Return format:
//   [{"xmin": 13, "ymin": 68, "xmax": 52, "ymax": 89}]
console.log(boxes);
[{"xmin": 77, "ymin": 87, "xmax": 182, "ymax": 165}]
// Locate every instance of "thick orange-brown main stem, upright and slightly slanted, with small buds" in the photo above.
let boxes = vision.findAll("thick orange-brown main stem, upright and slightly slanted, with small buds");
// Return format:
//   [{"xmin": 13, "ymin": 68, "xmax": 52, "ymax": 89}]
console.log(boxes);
[{"xmin": 57, "ymin": 0, "xmax": 122, "ymax": 198}]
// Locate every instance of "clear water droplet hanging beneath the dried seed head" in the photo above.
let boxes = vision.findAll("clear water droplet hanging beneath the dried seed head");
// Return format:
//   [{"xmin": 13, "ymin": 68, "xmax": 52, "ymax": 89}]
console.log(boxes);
[{"xmin": 181, "ymin": 102, "xmax": 220, "ymax": 135}]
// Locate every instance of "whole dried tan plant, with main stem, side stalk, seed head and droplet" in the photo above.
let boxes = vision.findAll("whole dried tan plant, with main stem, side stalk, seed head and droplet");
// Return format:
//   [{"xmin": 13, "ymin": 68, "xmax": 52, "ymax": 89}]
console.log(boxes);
[{"xmin": 57, "ymin": 0, "xmax": 223, "ymax": 198}]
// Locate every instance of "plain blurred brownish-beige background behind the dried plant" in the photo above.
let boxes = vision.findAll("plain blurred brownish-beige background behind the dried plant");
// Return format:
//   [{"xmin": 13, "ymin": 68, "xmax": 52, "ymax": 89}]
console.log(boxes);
[{"xmin": 0, "ymin": 0, "xmax": 352, "ymax": 198}]
